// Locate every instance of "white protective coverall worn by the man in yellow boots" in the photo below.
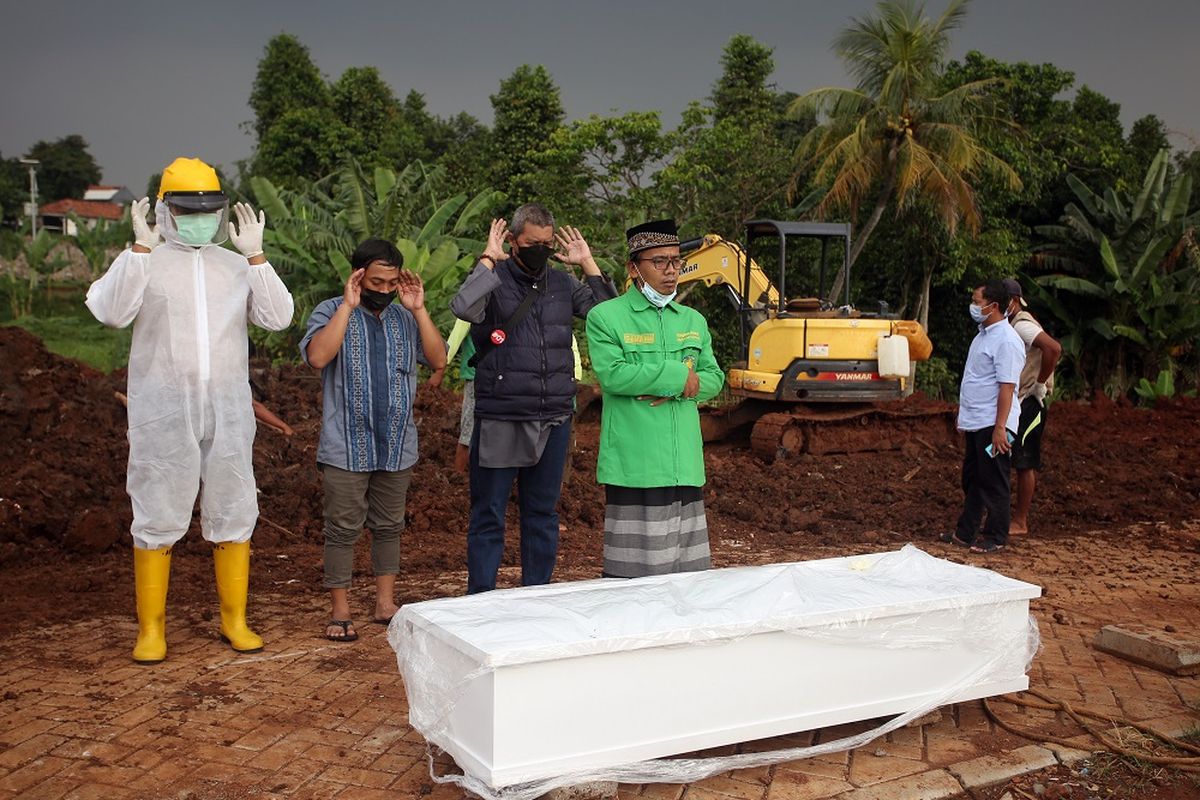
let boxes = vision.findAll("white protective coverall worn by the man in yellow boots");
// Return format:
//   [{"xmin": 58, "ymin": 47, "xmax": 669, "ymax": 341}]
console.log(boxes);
[{"xmin": 86, "ymin": 235, "xmax": 293, "ymax": 549}]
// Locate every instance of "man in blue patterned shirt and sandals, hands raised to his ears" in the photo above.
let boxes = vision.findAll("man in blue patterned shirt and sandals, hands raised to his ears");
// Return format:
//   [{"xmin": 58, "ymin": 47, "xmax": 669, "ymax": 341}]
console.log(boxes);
[{"xmin": 300, "ymin": 239, "xmax": 446, "ymax": 642}]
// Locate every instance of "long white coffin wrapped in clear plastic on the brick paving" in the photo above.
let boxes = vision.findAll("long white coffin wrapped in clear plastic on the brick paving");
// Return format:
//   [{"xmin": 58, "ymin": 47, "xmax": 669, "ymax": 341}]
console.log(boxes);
[{"xmin": 389, "ymin": 546, "xmax": 1040, "ymax": 788}]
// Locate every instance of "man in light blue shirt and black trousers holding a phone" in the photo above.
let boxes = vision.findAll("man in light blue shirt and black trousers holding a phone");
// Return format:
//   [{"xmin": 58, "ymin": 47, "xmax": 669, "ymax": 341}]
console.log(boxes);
[{"xmin": 941, "ymin": 281, "xmax": 1025, "ymax": 553}]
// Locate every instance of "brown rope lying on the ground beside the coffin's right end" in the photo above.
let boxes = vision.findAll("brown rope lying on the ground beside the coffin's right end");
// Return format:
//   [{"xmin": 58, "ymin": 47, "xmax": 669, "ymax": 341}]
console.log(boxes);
[{"xmin": 983, "ymin": 688, "xmax": 1200, "ymax": 774}]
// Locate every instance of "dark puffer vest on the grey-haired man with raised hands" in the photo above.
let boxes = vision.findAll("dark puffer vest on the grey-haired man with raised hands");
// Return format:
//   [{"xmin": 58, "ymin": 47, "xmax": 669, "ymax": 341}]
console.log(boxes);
[{"xmin": 470, "ymin": 258, "xmax": 575, "ymax": 420}]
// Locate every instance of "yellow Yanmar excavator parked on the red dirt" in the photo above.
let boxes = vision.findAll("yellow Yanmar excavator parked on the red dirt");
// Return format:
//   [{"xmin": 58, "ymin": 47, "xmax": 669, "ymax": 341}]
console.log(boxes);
[{"xmin": 678, "ymin": 219, "xmax": 946, "ymax": 461}]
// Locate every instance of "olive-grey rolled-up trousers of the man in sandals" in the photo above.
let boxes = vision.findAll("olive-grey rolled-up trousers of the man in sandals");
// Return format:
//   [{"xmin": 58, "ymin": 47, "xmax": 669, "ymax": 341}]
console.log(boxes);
[{"xmin": 320, "ymin": 464, "xmax": 413, "ymax": 589}]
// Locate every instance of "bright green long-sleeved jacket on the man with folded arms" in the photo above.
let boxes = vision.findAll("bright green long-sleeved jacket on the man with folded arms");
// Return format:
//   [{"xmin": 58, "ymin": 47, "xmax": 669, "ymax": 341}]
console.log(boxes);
[{"xmin": 587, "ymin": 287, "xmax": 725, "ymax": 488}]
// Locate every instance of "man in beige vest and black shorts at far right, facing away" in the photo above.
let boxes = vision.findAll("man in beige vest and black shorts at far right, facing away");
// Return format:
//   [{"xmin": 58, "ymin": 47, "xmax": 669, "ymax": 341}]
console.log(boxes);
[{"xmin": 1004, "ymin": 278, "xmax": 1062, "ymax": 536}]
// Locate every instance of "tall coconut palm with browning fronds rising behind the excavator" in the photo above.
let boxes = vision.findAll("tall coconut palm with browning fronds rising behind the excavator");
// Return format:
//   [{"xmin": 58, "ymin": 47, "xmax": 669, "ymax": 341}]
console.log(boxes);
[{"xmin": 790, "ymin": 0, "xmax": 1020, "ymax": 307}]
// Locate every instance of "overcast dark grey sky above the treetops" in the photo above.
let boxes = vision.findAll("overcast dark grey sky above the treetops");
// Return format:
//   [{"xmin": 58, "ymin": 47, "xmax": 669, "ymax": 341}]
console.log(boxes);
[{"xmin": 0, "ymin": 0, "xmax": 1200, "ymax": 192}]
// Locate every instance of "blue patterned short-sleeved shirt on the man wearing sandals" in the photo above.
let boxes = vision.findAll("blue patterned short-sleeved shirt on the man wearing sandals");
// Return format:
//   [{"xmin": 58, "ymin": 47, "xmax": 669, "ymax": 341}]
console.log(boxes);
[{"xmin": 300, "ymin": 297, "xmax": 428, "ymax": 473}]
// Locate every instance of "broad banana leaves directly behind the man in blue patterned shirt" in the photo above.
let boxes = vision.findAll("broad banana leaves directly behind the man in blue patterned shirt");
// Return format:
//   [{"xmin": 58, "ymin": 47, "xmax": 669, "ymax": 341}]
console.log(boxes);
[{"xmin": 251, "ymin": 158, "xmax": 503, "ymax": 359}]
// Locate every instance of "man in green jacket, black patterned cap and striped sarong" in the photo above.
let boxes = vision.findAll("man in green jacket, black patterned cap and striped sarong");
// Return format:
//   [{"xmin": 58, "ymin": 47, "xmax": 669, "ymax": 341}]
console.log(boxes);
[{"xmin": 587, "ymin": 219, "xmax": 725, "ymax": 578}]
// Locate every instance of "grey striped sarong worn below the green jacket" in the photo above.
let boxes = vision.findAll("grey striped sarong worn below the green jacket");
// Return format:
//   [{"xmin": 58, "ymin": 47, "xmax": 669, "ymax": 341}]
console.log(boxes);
[{"xmin": 604, "ymin": 486, "xmax": 712, "ymax": 578}]
